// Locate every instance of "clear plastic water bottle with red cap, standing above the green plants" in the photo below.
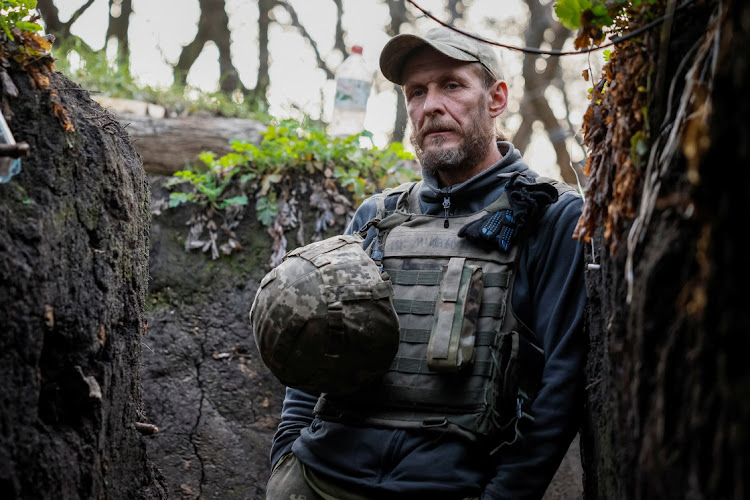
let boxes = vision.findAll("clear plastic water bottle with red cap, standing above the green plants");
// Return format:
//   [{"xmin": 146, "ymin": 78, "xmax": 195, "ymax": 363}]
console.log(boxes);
[{"xmin": 328, "ymin": 45, "xmax": 375, "ymax": 137}]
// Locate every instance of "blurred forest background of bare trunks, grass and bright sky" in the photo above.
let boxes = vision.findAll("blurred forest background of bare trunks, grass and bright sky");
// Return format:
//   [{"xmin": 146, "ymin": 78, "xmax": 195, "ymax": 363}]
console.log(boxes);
[{"xmin": 37, "ymin": 0, "xmax": 604, "ymax": 184}]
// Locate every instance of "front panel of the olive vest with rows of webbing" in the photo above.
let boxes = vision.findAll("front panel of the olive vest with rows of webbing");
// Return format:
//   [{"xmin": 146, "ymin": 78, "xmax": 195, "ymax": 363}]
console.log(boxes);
[{"xmin": 317, "ymin": 205, "xmax": 517, "ymax": 436}]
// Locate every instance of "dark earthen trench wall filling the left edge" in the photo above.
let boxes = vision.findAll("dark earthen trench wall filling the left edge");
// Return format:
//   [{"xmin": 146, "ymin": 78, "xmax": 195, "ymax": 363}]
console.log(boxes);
[{"xmin": 0, "ymin": 57, "xmax": 166, "ymax": 499}]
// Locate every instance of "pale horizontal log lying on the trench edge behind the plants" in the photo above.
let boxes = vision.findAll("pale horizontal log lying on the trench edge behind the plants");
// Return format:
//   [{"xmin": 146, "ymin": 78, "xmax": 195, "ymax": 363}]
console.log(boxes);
[{"xmin": 110, "ymin": 113, "xmax": 267, "ymax": 175}]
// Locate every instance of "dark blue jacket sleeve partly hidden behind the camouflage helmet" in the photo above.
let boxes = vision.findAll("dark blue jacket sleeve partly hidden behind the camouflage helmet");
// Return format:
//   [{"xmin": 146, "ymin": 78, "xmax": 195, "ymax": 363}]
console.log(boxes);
[{"xmin": 270, "ymin": 199, "xmax": 376, "ymax": 467}]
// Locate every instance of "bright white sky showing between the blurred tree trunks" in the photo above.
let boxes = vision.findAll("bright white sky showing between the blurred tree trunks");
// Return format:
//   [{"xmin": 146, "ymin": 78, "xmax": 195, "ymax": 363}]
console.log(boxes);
[{"xmin": 55, "ymin": 0, "xmax": 602, "ymax": 178}]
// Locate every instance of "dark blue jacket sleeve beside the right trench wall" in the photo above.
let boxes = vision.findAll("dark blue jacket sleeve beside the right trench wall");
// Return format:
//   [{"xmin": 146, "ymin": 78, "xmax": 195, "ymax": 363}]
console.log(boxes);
[{"xmin": 482, "ymin": 194, "xmax": 587, "ymax": 500}]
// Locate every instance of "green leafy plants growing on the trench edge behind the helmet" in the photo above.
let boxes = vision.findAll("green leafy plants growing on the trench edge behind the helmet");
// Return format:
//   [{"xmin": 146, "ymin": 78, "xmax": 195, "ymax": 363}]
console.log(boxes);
[{"xmin": 167, "ymin": 120, "xmax": 416, "ymax": 257}]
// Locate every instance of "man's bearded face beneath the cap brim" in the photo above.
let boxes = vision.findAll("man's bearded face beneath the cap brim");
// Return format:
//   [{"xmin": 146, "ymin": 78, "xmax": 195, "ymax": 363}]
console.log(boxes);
[{"xmin": 403, "ymin": 48, "xmax": 504, "ymax": 178}]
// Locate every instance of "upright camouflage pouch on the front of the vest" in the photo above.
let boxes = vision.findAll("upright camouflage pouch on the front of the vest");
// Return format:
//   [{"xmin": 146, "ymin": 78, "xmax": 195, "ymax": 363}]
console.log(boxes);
[{"xmin": 427, "ymin": 258, "xmax": 484, "ymax": 373}]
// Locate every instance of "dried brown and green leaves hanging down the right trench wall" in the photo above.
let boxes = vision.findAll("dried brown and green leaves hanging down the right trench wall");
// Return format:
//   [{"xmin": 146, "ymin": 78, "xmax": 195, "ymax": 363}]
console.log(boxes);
[{"xmin": 555, "ymin": 0, "xmax": 663, "ymax": 254}]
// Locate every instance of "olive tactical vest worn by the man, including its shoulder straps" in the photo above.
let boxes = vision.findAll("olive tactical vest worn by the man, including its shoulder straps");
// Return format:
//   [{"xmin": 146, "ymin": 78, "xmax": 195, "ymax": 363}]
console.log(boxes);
[{"xmin": 315, "ymin": 177, "xmax": 565, "ymax": 446}]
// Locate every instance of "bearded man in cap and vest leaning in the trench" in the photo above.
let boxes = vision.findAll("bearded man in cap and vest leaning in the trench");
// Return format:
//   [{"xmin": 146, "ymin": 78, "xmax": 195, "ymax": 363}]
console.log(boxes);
[{"xmin": 267, "ymin": 28, "xmax": 586, "ymax": 499}]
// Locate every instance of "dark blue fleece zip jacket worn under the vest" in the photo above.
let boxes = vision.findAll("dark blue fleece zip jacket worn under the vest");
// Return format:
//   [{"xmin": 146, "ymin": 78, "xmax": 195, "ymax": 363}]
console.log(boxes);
[{"xmin": 271, "ymin": 142, "xmax": 587, "ymax": 500}]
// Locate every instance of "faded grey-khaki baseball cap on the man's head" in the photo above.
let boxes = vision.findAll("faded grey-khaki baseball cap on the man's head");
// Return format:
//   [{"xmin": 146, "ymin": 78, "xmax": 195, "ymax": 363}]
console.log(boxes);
[{"xmin": 380, "ymin": 26, "xmax": 503, "ymax": 85}]
